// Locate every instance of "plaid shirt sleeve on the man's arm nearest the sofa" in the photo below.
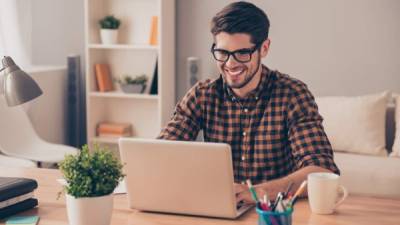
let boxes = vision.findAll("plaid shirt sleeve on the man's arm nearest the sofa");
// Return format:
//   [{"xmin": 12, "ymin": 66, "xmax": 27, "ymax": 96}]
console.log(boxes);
[{"xmin": 288, "ymin": 84, "xmax": 340, "ymax": 174}]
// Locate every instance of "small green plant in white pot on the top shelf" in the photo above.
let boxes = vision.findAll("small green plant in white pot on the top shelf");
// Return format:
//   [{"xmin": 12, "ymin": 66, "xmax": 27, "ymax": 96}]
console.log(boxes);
[{"xmin": 99, "ymin": 15, "xmax": 121, "ymax": 44}]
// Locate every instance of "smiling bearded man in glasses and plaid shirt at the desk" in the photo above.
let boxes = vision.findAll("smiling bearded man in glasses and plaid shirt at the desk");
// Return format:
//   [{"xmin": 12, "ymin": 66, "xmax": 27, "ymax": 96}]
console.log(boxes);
[{"xmin": 159, "ymin": 2, "xmax": 339, "ymax": 202}]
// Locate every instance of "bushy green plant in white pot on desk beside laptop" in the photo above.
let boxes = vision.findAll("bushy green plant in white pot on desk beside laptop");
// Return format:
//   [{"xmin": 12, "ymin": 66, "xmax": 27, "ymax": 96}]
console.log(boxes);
[{"xmin": 59, "ymin": 145, "xmax": 124, "ymax": 225}]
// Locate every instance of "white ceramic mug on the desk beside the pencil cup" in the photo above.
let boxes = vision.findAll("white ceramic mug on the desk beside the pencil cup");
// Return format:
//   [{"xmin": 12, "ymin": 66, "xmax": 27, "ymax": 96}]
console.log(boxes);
[{"xmin": 307, "ymin": 173, "xmax": 348, "ymax": 214}]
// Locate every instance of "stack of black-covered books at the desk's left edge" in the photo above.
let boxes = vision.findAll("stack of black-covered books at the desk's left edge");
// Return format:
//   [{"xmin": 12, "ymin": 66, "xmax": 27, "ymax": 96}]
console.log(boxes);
[{"xmin": 0, "ymin": 177, "xmax": 38, "ymax": 219}]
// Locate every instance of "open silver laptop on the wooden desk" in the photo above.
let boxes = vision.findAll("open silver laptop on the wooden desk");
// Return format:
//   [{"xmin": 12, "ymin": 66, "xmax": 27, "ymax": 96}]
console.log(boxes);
[{"xmin": 119, "ymin": 138, "xmax": 253, "ymax": 219}]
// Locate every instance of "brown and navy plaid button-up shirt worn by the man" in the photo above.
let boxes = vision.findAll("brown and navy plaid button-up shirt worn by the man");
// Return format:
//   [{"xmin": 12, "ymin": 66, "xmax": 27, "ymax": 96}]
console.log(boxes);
[{"xmin": 158, "ymin": 66, "xmax": 339, "ymax": 184}]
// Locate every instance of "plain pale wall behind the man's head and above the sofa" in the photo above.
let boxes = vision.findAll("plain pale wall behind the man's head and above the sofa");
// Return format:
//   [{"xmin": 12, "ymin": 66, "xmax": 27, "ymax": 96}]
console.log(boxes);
[{"xmin": 177, "ymin": 0, "xmax": 400, "ymax": 99}]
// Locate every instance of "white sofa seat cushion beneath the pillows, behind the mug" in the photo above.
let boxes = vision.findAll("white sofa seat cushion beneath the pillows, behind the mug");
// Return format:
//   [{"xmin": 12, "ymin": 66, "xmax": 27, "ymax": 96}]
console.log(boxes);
[{"xmin": 334, "ymin": 152, "xmax": 400, "ymax": 197}]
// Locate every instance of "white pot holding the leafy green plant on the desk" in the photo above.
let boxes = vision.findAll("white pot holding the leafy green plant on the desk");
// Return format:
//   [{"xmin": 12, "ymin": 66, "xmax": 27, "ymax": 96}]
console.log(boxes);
[{"xmin": 66, "ymin": 194, "xmax": 113, "ymax": 225}]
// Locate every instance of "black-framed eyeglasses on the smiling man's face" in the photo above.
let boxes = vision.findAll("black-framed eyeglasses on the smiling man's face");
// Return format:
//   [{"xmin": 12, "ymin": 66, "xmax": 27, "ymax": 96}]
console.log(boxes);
[{"xmin": 211, "ymin": 43, "xmax": 261, "ymax": 63}]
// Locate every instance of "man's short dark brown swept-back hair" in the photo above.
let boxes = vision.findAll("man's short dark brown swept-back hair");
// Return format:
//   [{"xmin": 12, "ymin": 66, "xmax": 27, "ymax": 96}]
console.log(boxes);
[{"xmin": 211, "ymin": 1, "xmax": 269, "ymax": 44}]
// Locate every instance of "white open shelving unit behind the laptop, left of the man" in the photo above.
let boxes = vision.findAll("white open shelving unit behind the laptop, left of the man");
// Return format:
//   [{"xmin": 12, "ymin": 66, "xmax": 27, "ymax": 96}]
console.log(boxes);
[{"xmin": 85, "ymin": 0, "xmax": 175, "ymax": 146}]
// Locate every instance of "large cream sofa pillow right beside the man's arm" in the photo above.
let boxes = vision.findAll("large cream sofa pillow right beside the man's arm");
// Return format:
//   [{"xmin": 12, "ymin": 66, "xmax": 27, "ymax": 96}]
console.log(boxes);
[{"xmin": 316, "ymin": 92, "xmax": 390, "ymax": 156}]
